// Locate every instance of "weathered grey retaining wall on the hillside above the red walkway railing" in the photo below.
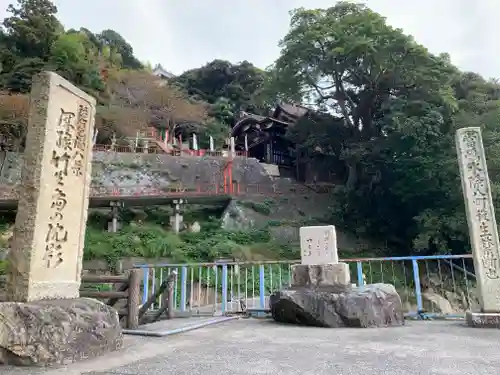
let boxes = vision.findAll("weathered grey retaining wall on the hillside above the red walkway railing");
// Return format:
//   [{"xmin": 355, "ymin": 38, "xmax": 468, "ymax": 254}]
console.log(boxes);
[{"xmin": 0, "ymin": 151, "xmax": 271, "ymax": 197}]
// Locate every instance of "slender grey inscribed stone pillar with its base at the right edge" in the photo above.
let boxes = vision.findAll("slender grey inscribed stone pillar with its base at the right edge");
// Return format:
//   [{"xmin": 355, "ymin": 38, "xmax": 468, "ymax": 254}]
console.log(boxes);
[{"xmin": 456, "ymin": 127, "xmax": 500, "ymax": 328}]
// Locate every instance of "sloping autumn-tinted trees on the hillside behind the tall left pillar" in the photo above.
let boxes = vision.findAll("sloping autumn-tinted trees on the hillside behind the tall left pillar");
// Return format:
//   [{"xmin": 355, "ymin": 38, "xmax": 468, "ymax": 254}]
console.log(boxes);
[{"xmin": 0, "ymin": 0, "xmax": 239, "ymax": 151}]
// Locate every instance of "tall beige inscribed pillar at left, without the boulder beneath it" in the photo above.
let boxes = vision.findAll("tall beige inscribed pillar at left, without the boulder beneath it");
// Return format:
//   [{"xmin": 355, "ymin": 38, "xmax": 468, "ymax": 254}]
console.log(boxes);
[{"xmin": 7, "ymin": 72, "xmax": 95, "ymax": 302}]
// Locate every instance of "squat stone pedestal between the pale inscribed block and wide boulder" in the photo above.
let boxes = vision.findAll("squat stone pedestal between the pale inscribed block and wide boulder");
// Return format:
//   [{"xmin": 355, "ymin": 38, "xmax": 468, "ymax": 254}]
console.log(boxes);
[{"xmin": 292, "ymin": 263, "xmax": 351, "ymax": 288}]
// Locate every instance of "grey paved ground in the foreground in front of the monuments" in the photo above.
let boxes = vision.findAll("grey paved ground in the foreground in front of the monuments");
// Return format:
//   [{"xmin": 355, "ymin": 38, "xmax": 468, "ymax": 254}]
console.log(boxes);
[{"xmin": 0, "ymin": 319, "xmax": 500, "ymax": 375}]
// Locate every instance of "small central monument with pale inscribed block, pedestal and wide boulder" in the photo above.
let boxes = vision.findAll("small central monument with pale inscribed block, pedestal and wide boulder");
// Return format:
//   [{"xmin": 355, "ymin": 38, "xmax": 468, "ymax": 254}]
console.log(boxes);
[{"xmin": 270, "ymin": 225, "xmax": 404, "ymax": 327}]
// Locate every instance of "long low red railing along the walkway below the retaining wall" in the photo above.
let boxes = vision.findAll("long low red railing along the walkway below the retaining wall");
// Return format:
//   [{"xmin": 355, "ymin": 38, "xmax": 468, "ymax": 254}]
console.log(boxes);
[{"xmin": 0, "ymin": 183, "xmax": 334, "ymax": 200}]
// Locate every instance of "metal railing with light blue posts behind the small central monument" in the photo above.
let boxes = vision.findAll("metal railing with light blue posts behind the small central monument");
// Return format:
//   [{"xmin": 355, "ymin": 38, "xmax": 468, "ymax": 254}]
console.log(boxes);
[{"xmin": 136, "ymin": 255, "xmax": 475, "ymax": 315}]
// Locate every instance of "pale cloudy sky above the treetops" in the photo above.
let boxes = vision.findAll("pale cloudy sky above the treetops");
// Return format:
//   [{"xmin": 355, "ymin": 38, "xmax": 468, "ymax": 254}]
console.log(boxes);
[{"xmin": 0, "ymin": 0, "xmax": 500, "ymax": 78}]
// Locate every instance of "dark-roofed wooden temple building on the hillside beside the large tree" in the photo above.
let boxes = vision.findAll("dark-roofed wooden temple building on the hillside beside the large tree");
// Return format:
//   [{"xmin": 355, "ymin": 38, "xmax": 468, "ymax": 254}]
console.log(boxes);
[{"xmin": 231, "ymin": 103, "xmax": 309, "ymax": 167}]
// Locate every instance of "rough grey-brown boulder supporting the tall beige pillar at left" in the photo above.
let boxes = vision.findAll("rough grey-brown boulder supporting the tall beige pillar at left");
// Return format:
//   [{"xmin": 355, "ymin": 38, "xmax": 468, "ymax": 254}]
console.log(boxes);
[{"xmin": 0, "ymin": 298, "xmax": 123, "ymax": 366}]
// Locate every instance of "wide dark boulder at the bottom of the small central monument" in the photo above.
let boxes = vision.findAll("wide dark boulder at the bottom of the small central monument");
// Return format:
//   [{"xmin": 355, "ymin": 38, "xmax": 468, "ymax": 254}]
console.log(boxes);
[{"xmin": 270, "ymin": 284, "xmax": 404, "ymax": 328}]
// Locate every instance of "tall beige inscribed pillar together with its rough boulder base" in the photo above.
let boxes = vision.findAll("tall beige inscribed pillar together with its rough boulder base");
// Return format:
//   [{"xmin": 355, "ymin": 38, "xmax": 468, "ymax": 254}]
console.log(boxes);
[{"xmin": 0, "ymin": 72, "xmax": 123, "ymax": 365}]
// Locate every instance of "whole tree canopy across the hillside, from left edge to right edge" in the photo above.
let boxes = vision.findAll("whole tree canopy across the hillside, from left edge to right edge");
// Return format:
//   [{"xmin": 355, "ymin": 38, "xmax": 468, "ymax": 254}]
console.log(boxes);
[{"xmin": 0, "ymin": 0, "xmax": 500, "ymax": 262}]
